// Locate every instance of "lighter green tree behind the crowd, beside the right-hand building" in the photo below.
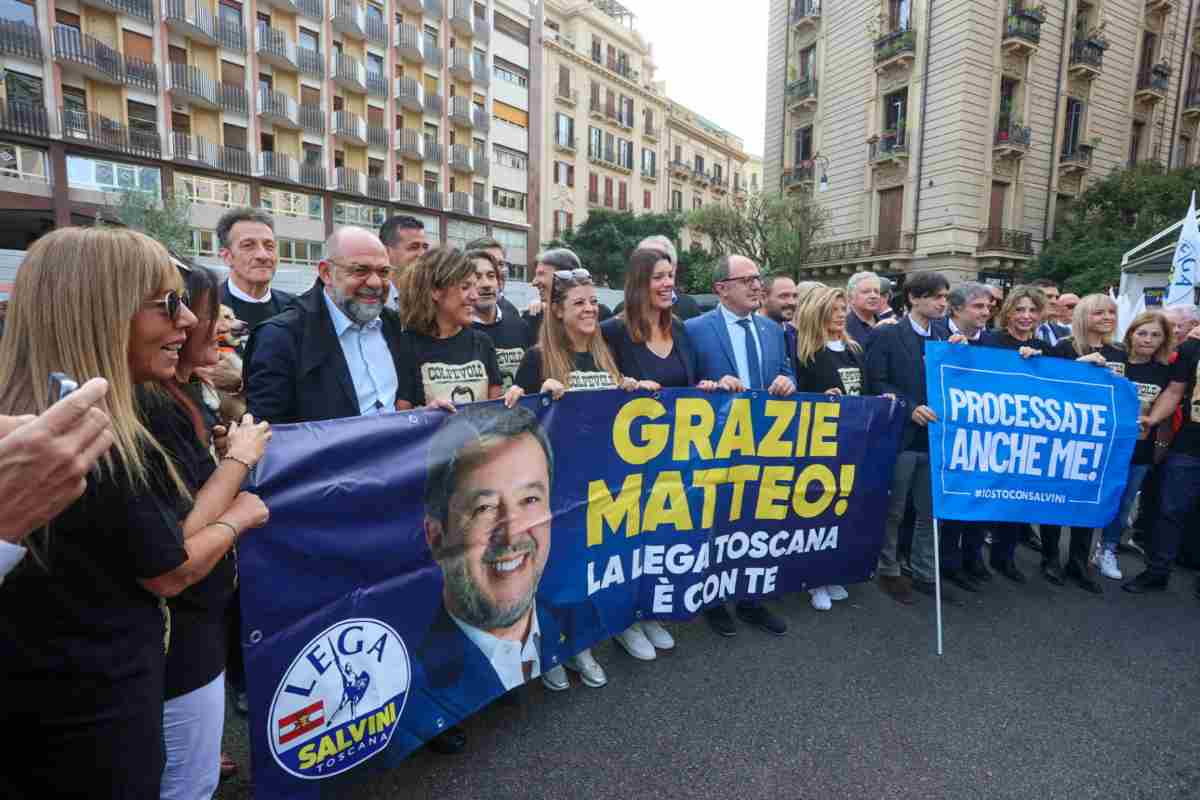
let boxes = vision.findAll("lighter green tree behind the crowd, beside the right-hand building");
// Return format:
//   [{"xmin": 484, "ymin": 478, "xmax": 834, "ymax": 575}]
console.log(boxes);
[{"xmin": 688, "ymin": 193, "xmax": 829, "ymax": 278}]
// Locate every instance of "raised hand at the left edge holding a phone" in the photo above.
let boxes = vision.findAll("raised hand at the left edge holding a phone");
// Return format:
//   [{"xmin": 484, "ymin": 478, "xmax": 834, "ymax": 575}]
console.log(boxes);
[{"xmin": 0, "ymin": 378, "xmax": 113, "ymax": 542}]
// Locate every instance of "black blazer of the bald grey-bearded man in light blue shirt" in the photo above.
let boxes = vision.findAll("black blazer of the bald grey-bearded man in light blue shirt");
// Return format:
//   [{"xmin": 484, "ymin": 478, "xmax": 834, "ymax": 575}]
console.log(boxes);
[{"xmin": 244, "ymin": 285, "xmax": 410, "ymax": 425}]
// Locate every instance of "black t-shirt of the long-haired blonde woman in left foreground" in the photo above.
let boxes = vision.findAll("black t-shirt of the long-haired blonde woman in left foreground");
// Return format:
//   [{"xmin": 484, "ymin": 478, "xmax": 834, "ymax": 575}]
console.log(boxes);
[{"xmin": 0, "ymin": 453, "xmax": 187, "ymax": 724}]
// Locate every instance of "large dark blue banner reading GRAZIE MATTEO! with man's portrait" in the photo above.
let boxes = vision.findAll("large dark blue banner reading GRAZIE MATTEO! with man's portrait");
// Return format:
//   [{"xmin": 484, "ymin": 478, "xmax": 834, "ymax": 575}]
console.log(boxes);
[{"xmin": 239, "ymin": 390, "xmax": 906, "ymax": 800}]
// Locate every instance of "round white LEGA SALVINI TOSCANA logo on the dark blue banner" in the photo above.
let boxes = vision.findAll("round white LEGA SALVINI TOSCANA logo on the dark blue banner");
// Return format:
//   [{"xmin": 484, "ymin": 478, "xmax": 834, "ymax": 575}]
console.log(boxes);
[{"xmin": 266, "ymin": 619, "xmax": 412, "ymax": 780}]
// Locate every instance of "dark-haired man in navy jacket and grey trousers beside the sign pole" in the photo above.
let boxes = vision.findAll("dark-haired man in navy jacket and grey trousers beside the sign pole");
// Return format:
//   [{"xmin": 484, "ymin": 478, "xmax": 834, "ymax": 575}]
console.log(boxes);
[{"xmin": 866, "ymin": 272, "xmax": 954, "ymax": 604}]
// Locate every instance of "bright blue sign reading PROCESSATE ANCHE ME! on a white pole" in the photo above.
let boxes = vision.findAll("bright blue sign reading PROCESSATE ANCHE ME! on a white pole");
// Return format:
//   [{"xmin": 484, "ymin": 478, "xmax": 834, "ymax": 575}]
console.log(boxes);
[{"xmin": 925, "ymin": 342, "xmax": 1139, "ymax": 528}]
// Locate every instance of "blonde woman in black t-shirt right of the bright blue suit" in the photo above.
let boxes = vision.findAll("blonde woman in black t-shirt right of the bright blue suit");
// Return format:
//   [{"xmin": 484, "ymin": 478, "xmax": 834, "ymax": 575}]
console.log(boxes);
[{"xmin": 792, "ymin": 291, "xmax": 864, "ymax": 612}]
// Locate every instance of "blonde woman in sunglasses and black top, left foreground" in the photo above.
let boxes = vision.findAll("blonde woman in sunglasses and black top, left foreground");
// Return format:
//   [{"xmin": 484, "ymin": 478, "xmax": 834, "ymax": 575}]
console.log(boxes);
[{"xmin": 0, "ymin": 228, "xmax": 266, "ymax": 800}]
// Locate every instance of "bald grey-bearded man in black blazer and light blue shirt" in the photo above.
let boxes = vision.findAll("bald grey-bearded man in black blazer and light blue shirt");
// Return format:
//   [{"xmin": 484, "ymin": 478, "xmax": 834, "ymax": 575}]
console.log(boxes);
[{"xmin": 246, "ymin": 227, "xmax": 412, "ymax": 425}]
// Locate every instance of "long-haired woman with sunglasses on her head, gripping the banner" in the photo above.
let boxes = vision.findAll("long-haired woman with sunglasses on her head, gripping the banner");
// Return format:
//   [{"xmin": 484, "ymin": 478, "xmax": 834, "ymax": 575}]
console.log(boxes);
[{"xmin": 514, "ymin": 269, "xmax": 647, "ymax": 692}]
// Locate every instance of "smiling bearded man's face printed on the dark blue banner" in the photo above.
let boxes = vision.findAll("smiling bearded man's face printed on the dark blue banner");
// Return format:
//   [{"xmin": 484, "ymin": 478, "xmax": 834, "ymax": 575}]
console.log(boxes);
[{"xmin": 425, "ymin": 433, "xmax": 551, "ymax": 636}]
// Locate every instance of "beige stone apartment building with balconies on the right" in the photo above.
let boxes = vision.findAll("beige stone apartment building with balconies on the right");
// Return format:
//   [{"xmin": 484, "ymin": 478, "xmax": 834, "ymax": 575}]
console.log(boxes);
[{"xmin": 763, "ymin": 0, "xmax": 1200, "ymax": 291}]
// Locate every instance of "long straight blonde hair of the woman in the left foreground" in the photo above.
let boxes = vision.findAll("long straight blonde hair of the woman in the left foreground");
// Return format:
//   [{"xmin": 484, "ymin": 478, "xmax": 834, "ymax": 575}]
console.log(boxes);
[{"xmin": 0, "ymin": 228, "xmax": 190, "ymax": 563}]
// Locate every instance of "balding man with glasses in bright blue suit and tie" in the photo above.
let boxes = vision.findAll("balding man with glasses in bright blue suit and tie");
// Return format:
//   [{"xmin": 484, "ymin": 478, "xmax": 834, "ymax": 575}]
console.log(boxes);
[{"xmin": 684, "ymin": 255, "xmax": 796, "ymax": 636}]
